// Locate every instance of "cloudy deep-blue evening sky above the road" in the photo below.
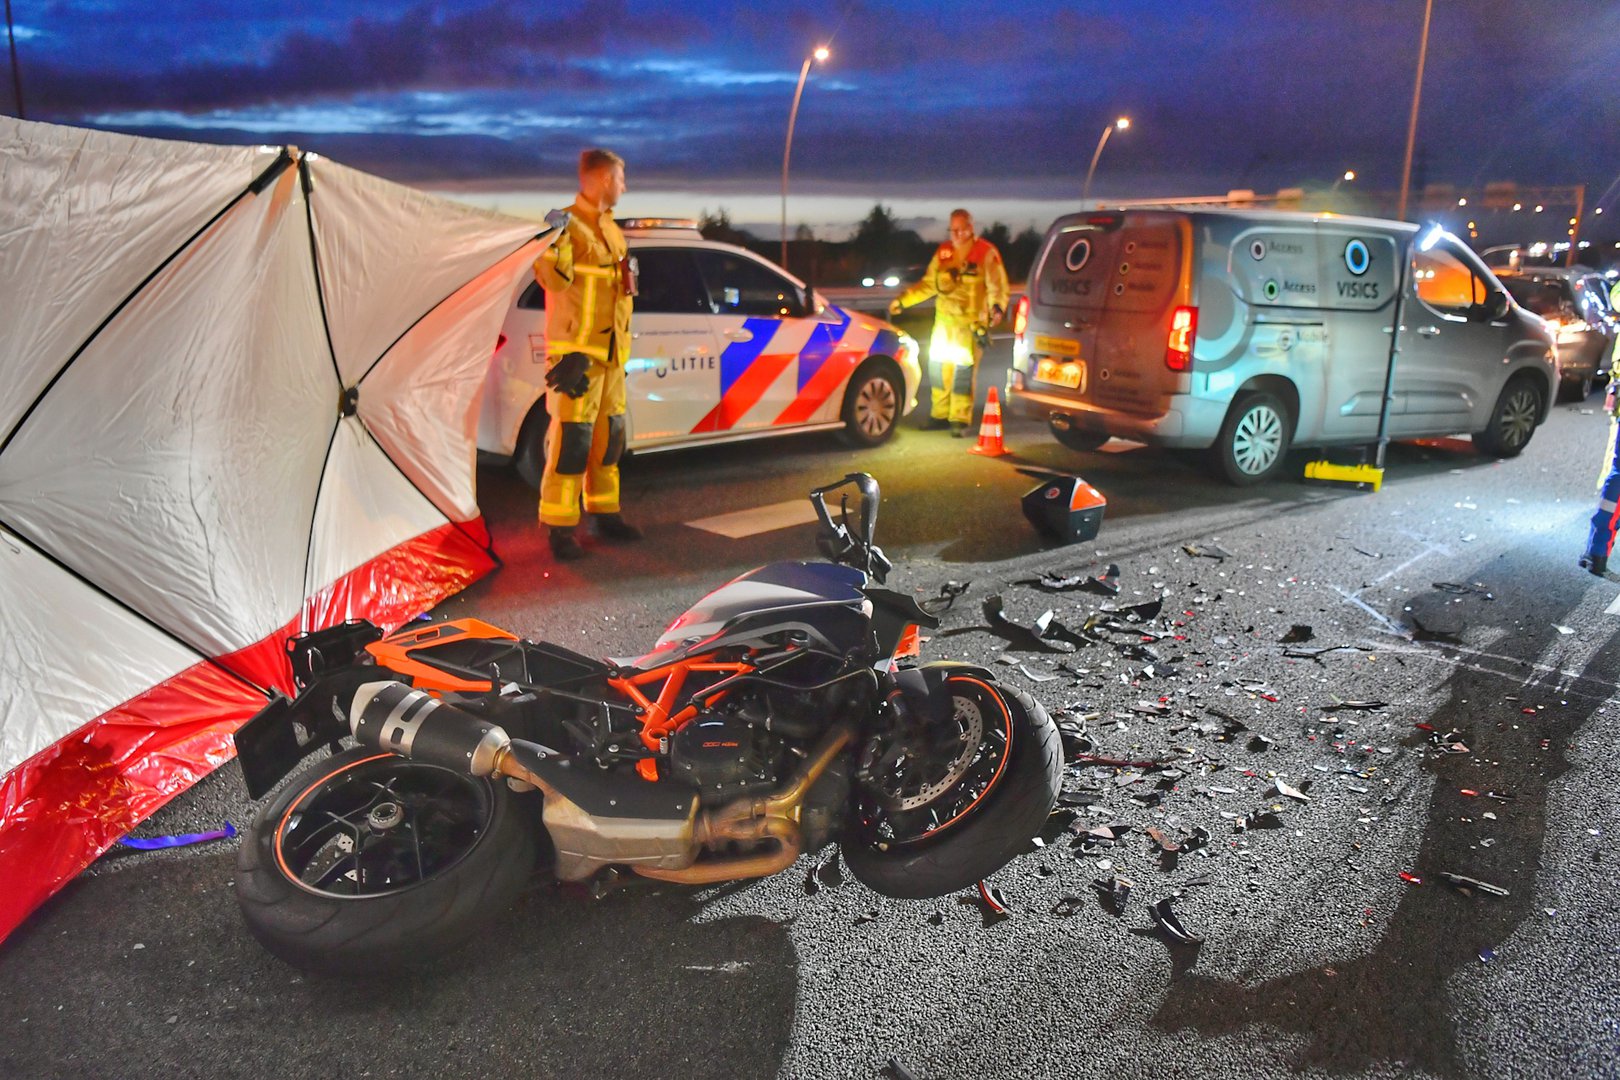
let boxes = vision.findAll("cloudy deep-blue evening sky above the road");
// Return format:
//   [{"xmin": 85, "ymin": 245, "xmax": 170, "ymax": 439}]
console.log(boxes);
[{"xmin": 0, "ymin": 0, "xmax": 1620, "ymax": 234}]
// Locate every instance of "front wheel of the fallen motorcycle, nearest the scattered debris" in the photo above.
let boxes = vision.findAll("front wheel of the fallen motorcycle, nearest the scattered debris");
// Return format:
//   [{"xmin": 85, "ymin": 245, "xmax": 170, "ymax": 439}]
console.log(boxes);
[{"xmin": 842, "ymin": 674, "xmax": 1063, "ymax": 900}]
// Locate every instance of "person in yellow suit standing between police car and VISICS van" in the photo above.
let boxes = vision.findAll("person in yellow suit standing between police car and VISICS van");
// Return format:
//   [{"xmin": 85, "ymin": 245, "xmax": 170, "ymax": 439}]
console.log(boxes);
[{"xmin": 889, "ymin": 210, "xmax": 1008, "ymax": 439}]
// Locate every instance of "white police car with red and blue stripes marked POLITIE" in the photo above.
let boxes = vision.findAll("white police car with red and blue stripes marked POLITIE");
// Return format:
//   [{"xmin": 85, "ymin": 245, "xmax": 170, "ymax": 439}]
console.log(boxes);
[{"xmin": 478, "ymin": 219, "xmax": 922, "ymax": 486}]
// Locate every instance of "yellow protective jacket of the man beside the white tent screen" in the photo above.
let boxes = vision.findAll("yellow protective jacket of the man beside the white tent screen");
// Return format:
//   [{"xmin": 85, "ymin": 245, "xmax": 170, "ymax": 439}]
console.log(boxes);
[{"xmin": 535, "ymin": 199, "xmax": 633, "ymax": 372}]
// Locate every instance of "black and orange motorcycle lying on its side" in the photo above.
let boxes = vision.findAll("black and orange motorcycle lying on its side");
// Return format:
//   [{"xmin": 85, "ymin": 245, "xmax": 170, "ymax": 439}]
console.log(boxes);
[{"xmin": 237, "ymin": 473, "xmax": 1061, "ymax": 975}]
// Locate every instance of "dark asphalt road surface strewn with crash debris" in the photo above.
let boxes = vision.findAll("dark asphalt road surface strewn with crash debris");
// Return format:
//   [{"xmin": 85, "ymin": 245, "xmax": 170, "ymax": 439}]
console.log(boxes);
[{"xmin": 0, "ymin": 340, "xmax": 1620, "ymax": 1078}]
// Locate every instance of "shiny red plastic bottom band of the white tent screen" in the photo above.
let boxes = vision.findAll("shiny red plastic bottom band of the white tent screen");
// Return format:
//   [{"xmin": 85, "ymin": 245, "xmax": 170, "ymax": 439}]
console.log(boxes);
[{"xmin": 0, "ymin": 521, "xmax": 496, "ymax": 941}]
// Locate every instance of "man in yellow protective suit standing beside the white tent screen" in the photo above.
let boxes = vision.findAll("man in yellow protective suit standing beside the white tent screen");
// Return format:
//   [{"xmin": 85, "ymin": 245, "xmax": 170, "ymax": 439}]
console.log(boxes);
[{"xmin": 535, "ymin": 149, "xmax": 642, "ymax": 559}]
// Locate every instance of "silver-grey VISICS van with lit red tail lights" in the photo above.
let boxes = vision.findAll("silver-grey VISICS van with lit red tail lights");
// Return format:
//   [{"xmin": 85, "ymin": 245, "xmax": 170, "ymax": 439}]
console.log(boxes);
[{"xmin": 1008, "ymin": 210, "xmax": 1558, "ymax": 484}]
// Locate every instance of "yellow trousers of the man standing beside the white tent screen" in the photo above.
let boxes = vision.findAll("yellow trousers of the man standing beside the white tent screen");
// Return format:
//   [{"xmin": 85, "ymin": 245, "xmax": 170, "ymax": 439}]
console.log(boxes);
[{"xmin": 539, "ymin": 353, "xmax": 627, "ymax": 526}]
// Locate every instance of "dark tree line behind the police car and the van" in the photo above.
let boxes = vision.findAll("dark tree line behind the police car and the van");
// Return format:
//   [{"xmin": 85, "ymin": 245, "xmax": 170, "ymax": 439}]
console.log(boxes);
[{"xmin": 698, "ymin": 202, "xmax": 1042, "ymax": 285}]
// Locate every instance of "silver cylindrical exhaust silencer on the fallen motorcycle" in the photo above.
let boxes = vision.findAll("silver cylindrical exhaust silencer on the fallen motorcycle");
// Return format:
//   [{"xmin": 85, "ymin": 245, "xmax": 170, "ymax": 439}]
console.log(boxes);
[{"xmin": 348, "ymin": 682, "xmax": 512, "ymax": 776}]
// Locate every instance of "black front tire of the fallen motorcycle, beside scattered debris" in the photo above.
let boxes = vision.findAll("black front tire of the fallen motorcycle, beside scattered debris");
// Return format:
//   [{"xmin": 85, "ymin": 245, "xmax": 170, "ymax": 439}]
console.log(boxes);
[{"xmin": 841, "ymin": 677, "xmax": 1063, "ymax": 900}]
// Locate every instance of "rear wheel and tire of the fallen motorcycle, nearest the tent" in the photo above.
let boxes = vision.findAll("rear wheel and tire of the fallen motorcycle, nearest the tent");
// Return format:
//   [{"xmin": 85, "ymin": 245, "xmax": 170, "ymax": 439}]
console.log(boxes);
[{"xmin": 237, "ymin": 748, "xmax": 541, "ymax": 976}]
